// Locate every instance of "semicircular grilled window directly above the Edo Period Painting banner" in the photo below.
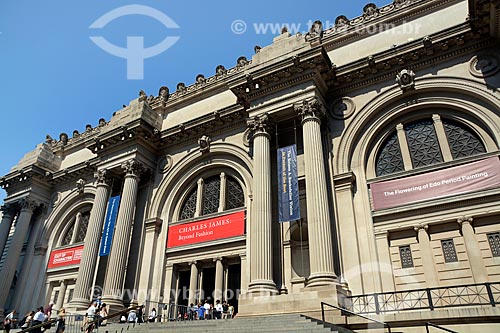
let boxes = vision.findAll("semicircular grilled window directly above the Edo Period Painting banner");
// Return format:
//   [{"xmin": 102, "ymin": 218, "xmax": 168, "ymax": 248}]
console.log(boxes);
[{"xmin": 375, "ymin": 115, "xmax": 486, "ymax": 176}]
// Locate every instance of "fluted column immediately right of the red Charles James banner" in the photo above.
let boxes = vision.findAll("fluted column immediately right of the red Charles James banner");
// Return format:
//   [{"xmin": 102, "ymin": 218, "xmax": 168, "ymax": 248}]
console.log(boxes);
[{"xmin": 248, "ymin": 114, "xmax": 277, "ymax": 294}]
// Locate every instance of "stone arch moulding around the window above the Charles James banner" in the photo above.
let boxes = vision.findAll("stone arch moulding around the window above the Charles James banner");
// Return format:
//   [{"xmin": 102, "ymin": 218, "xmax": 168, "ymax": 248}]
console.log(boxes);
[{"xmin": 149, "ymin": 143, "xmax": 252, "ymax": 222}]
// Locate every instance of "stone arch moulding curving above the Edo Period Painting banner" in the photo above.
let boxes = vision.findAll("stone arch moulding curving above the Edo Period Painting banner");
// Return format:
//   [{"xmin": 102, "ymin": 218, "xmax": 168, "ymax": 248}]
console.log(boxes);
[{"xmin": 334, "ymin": 77, "xmax": 500, "ymax": 178}]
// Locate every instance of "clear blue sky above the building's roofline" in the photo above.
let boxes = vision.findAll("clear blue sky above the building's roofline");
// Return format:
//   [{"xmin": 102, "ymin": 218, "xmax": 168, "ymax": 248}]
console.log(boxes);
[{"xmin": 0, "ymin": 0, "xmax": 391, "ymax": 198}]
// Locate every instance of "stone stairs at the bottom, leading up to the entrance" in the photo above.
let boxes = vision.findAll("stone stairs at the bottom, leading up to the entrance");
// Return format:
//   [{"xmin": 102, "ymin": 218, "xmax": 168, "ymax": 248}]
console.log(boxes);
[{"xmin": 111, "ymin": 314, "xmax": 354, "ymax": 333}]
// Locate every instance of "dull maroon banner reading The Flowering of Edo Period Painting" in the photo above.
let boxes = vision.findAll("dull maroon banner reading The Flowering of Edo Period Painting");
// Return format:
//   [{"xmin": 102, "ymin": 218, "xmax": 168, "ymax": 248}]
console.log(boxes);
[{"xmin": 370, "ymin": 157, "xmax": 500, "ymax": 210}]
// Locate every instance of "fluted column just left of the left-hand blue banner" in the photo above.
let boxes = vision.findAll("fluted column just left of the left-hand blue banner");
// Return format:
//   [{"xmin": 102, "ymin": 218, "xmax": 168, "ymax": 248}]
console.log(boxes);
[{"xmin": 70, "ymin": 170, "xmax": 110, "ymax": 310}]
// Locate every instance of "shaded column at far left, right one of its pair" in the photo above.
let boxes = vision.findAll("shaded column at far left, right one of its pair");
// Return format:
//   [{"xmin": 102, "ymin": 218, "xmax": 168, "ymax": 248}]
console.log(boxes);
[{"xmin": 0, "ymin": 199, "xmax": 39, "ymax": 314}]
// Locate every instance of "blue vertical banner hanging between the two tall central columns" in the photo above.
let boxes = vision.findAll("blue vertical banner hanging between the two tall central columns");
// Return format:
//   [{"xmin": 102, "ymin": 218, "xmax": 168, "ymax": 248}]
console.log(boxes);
[{"xmin": 278, "ymin": 145, "xmax": 300, "ymax": 223}]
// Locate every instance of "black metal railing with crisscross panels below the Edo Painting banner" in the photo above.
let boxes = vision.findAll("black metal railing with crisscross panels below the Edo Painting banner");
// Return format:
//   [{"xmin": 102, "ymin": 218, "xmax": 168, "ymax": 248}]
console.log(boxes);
[{"xmin": 342, "ymin": 282, "xmax": 500, "ymax": 314}]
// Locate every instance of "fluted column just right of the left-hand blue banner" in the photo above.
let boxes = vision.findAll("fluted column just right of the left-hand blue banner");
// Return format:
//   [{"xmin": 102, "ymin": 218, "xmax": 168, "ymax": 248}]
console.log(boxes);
[{"xmin": 102, "ymin": 160, "xmax": 143, "ymax": 310}]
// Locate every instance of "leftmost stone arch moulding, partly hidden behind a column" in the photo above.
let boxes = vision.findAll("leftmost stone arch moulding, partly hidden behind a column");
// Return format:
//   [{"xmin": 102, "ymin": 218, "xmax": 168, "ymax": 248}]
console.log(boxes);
[{"xmin": 38, "ymin": 186, "xmax": 95, "ymax": 253}]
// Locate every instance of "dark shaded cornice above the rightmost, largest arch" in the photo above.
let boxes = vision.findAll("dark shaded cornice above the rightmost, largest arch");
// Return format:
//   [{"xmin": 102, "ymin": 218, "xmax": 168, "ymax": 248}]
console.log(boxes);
[{"xmin": 327, "ymin": 22, "xmax": 495, "ymax": 95}]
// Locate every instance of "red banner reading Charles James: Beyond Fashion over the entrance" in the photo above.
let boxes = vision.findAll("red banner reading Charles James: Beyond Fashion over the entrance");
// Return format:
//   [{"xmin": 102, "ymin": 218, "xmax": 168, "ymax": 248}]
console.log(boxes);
[{"xmin": 167, "ymin": 211, "xmax": 245, "ymax": 248}]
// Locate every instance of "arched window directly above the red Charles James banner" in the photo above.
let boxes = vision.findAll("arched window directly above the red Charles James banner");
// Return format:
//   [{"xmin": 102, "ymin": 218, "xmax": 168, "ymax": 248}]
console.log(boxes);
[{"xmin": 179, "ymin": 172, "xmax": 245, "ymax": 220}]
